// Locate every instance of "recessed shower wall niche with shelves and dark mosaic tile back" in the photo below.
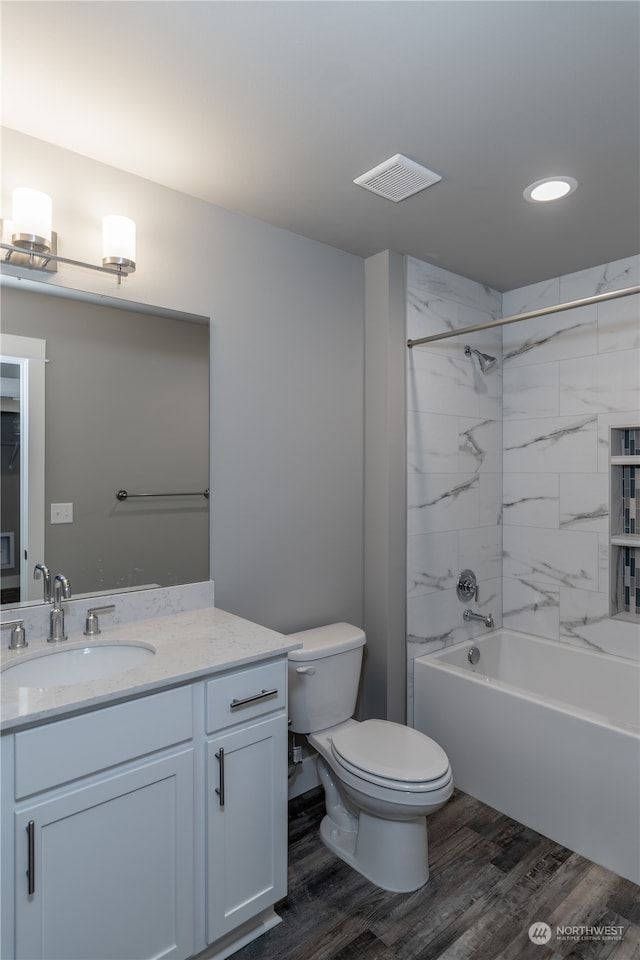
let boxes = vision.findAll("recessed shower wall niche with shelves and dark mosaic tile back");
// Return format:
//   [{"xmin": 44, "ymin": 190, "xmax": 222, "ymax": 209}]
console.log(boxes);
[{"xmin": 609, "ymin": 426, "xmax": 640, "ymax": 623}]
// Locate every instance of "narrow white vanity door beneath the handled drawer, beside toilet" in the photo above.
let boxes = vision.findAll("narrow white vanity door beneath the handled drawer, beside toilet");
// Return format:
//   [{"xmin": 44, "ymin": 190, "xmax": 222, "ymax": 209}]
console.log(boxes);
[{"xmin": 207, "ymin": 714, "xmax": 287, "ymax": 943}]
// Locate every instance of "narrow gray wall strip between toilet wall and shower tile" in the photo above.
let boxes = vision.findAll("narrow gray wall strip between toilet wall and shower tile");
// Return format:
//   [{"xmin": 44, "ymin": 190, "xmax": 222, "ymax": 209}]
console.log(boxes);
[{"xmin": 362, "ymin": 251, "xmax": 407, "ymax": 723}]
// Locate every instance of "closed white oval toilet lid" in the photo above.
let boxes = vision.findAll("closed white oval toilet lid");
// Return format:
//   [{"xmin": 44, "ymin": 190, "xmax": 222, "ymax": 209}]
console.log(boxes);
[{"xmin": 332, "ymin": 720, "xmax": 449, "ymax": 783}]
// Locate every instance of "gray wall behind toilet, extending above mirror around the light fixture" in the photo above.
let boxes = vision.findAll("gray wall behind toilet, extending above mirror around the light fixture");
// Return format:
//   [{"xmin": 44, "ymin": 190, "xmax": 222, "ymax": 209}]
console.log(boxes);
[{"xmin": 1, "ymin": 130, "xmax": 364, "ymax": 631}]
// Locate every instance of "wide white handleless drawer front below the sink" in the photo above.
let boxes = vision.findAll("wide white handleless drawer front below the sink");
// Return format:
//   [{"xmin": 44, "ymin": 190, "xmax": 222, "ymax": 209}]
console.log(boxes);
[{"xmin": 15, "ymin": 686, "xmax": 193, "ymax": 800}]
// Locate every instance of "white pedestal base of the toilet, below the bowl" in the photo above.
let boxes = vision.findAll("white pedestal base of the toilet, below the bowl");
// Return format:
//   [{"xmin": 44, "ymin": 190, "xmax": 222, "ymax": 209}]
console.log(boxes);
[{"xmin": 320, "ymin": 812, "xmax": 429, "ymax": 893}]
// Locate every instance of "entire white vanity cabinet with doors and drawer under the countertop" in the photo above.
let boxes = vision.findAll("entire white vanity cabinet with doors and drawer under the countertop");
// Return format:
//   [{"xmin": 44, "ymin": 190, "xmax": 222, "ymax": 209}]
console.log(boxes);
[{"xmin": 0, "ymin": 650, "xmax": 287, "ymax": 960}]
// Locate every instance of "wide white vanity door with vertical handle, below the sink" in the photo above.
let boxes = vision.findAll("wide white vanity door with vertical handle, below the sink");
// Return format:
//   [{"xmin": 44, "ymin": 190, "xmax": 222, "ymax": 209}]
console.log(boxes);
[{"xmin": 16, "ymin": 749, "xmax": 194, "ymax": 960}]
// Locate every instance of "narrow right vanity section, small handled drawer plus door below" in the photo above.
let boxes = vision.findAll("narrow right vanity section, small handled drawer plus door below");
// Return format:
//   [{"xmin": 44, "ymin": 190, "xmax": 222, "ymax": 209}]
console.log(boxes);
[{"xmin": 206, "ymin": 660, "xmax": 287, "ymax": 944}]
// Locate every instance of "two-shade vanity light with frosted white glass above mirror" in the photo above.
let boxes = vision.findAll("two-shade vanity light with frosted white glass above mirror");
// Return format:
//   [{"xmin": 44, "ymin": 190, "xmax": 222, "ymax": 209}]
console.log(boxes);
[{"xmin": 0, "ymin": 187, "xmax": 136, "ymax": 284}]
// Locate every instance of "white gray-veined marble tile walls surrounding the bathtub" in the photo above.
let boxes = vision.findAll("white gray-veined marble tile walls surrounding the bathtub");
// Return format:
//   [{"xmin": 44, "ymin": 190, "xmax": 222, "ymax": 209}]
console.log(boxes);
[{"xmin": 406, "ymin": 257, "xmax": 640, "ymax": 716}]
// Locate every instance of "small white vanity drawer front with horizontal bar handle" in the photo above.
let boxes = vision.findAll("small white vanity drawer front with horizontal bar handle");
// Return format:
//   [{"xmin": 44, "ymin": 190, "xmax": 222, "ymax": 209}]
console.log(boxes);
[{"xmin": 206, "ymin": 660, "xmax": 287, "ymax": 733}]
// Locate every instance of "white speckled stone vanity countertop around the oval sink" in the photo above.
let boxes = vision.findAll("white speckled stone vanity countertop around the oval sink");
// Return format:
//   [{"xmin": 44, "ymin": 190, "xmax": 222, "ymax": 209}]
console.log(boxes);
[{"xmin": 0, "ymin": 607, "xmax": 300, "ymax": 732}]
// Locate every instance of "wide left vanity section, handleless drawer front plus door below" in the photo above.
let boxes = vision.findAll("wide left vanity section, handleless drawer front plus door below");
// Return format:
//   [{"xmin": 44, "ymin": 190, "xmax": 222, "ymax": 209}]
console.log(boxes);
[{"xmin": 6, "ymin": 686, "xmax": 194, "ymax": 960}]
